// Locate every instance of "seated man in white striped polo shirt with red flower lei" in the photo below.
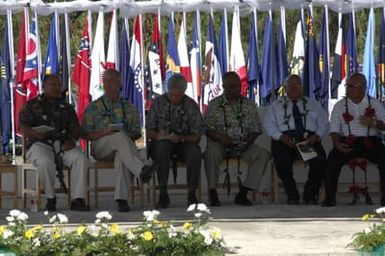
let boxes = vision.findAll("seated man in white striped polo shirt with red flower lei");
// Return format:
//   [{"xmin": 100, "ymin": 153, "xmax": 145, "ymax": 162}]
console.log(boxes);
[{"xmin": 322, "ymin": 73, "xmax": 385, "ymax": 207}]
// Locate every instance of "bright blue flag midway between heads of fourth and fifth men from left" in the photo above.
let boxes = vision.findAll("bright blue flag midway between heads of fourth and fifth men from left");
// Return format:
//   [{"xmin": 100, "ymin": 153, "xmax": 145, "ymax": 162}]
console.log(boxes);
[{"xmin": 259, "ymin": 11, "xmax": 277, "ymax": 98}]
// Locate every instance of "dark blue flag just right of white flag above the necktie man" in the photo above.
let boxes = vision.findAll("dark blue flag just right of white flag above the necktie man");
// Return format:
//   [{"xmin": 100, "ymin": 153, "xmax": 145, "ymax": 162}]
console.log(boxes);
[{"xmin": 303, "ymin": 14, "xmax": 321, "ymax": 100}]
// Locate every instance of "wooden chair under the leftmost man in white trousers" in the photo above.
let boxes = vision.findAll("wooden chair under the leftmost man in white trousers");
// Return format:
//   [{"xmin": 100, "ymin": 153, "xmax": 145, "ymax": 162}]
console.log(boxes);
[{"xmin": 21, "ymin": 137, "xmax": 71, "ymax": 208}]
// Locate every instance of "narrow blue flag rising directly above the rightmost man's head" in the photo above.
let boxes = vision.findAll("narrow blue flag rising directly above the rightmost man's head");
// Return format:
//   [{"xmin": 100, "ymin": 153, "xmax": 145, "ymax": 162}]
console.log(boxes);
[{"xmin": 345, "ymin": 13, "xmax": 358, "ymax": 79}]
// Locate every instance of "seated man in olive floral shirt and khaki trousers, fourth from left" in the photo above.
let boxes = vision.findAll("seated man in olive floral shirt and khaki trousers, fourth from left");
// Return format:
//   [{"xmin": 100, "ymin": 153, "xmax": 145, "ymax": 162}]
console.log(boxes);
[{"xmin": 204, "ymin": 72, "xmax": 270, "ymax": 206}]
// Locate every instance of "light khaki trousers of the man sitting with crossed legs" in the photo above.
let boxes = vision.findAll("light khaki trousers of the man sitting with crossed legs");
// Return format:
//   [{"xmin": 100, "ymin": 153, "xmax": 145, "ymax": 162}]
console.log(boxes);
[{"xmin": 92, "ymin": 132, "xmax": 144, "ymax": 200}]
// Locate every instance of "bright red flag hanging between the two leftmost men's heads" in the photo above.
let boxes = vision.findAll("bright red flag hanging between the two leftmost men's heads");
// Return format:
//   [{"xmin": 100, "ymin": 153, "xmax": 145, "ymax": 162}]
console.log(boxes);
[{"xmin": 72, "ymin": 18, "xmax": 91, "ymax": 125}]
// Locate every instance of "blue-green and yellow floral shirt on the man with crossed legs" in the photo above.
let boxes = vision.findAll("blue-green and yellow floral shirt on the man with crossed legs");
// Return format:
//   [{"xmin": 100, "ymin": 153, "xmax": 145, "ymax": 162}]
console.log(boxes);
[{"xmin": 82, "ymin": 95, "xmax": 140, "ymax": 134}]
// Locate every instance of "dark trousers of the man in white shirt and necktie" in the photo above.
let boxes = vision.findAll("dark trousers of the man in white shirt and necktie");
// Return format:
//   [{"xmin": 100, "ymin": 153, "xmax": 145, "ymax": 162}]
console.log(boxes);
[{"xmin": 271, "ymin": 140, "xmax": 326, "ymax": 200}]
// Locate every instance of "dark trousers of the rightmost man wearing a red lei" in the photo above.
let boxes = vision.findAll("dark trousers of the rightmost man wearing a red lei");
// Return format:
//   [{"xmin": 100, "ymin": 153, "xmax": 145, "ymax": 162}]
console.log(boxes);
[{"xmin": 325, "ymin": 137, "xmax": 385, "ymax": 200}]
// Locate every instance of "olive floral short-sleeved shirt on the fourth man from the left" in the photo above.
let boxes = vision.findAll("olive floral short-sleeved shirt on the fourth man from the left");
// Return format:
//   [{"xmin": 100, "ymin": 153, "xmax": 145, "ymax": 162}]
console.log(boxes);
[{"xmin": 204, "ymin": 95, "xmax": 262, "ymax": 140}]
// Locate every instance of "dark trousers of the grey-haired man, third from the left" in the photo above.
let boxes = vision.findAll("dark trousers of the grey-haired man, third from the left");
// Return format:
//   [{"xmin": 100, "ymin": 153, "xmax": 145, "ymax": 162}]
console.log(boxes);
[{"xmin": 150, "ymin": 140, "xmax": 202, "ymax": 192}]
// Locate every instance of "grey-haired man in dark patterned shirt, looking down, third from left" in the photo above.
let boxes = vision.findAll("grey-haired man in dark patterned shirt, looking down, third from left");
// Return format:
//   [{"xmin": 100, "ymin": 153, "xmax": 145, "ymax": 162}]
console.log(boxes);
[{"xmin": 146, "ymin": 74, "xmax": 202, "ymax": 208}]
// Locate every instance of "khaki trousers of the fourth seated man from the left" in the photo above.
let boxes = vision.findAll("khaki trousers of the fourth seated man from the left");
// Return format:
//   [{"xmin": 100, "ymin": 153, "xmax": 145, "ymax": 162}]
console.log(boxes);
[{"xmin": 204, "ymin": 141, "xmax": 270, "ymax": 190}]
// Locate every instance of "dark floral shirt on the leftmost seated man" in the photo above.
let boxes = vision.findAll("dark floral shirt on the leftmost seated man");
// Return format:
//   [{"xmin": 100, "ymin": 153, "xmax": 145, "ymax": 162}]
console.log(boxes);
[{"xmin": 19, "ymin": 94, "xmax": 80, "ymax": 148}]
